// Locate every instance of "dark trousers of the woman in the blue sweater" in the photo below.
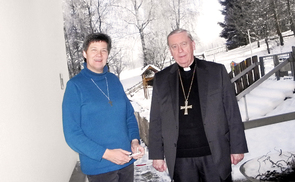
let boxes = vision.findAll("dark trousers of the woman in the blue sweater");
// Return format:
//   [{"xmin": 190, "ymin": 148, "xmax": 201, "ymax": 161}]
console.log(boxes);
[{"xmin": 87, "ymin": 164, "xmax": 134, "ymax": 182}]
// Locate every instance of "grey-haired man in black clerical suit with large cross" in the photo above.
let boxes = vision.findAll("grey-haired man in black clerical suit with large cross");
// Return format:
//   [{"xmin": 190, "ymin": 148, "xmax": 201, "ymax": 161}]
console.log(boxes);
[{"xmin": 149, "ymin": 29, "xmax": 248, "ymax": 182}]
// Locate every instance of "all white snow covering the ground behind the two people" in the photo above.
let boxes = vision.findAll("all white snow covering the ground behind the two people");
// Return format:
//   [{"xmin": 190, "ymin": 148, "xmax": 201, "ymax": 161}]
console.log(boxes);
[{"xmin": 121, "ymin": 32, "xmax": 295, "ymax": 182}]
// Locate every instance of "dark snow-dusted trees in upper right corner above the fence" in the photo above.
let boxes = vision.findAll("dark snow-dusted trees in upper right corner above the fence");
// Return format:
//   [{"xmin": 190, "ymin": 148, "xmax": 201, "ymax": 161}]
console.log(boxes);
[{"xmin": 219, "ymin": 0, "xmax": 295, "ymax": 49}]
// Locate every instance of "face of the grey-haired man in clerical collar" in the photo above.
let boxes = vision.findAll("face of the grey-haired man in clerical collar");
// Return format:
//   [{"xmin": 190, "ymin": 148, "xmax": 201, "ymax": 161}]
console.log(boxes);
[{"xmin": 168, "ymin": 32, "xmax": 195, "ymax": 68}]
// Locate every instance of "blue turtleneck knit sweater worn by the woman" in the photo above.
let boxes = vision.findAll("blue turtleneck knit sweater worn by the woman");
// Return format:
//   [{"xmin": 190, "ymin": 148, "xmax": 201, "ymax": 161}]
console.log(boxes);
[{"xmin": 62, "ymin": 64, "xmax": 139, "ymax": 175}]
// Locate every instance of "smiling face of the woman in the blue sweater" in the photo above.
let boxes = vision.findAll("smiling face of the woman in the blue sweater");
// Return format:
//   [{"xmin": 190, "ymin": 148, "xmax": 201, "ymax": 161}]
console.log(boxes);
[{"xmin": 83, "ymin": 41, "xmax": 109, "ymax": 73}]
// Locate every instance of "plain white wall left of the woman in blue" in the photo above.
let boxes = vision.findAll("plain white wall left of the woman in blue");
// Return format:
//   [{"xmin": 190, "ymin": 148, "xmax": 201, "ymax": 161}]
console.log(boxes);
[{"xmin": 0, "ymin": 0, "xmax": 77, "ymax": 182}]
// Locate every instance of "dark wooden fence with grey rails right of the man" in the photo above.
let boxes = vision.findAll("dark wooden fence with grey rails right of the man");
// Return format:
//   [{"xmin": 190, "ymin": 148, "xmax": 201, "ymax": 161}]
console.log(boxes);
[{"xmin": 229, "ymin": 47, "xmax": 295, "ymax": 125}]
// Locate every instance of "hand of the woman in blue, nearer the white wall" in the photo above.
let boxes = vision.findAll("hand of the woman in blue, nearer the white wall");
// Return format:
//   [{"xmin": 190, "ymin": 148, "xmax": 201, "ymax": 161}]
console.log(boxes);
[{"xmin": 102, "ymin": 149, "xmax": 131, "ymax": 165}]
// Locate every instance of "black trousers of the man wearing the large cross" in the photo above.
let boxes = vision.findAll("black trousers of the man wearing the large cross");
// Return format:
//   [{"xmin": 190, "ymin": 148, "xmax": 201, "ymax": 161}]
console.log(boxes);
[{"xmin": 173, "ymin": 155, "xmax": 232, "ymax": 182}]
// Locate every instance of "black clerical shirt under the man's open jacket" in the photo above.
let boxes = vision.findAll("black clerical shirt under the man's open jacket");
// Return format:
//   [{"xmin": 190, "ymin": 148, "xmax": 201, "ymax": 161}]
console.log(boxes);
[{"xmin": 176, "ymin": 62, "xmax": 211, "ymax": 158}]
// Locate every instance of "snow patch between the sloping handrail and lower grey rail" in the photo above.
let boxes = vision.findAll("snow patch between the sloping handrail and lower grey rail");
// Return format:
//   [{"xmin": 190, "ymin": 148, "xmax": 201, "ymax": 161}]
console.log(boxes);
[{"xmin": 238, "ymin": 77, "xmax": 295, "ymax": 121}]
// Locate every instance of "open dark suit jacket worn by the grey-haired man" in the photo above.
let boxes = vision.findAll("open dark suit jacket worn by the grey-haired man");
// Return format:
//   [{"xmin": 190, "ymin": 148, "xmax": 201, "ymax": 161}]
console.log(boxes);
[{"xmin": 148, "ymin": 58, "xmax": 248, "ymax": 179}]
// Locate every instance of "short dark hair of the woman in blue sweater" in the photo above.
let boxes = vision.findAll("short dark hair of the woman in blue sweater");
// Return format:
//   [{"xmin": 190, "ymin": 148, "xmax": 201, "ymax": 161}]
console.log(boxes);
[{"xmin": 83, "ymin": 33, "xmax": 112, "ymax": 53}]
